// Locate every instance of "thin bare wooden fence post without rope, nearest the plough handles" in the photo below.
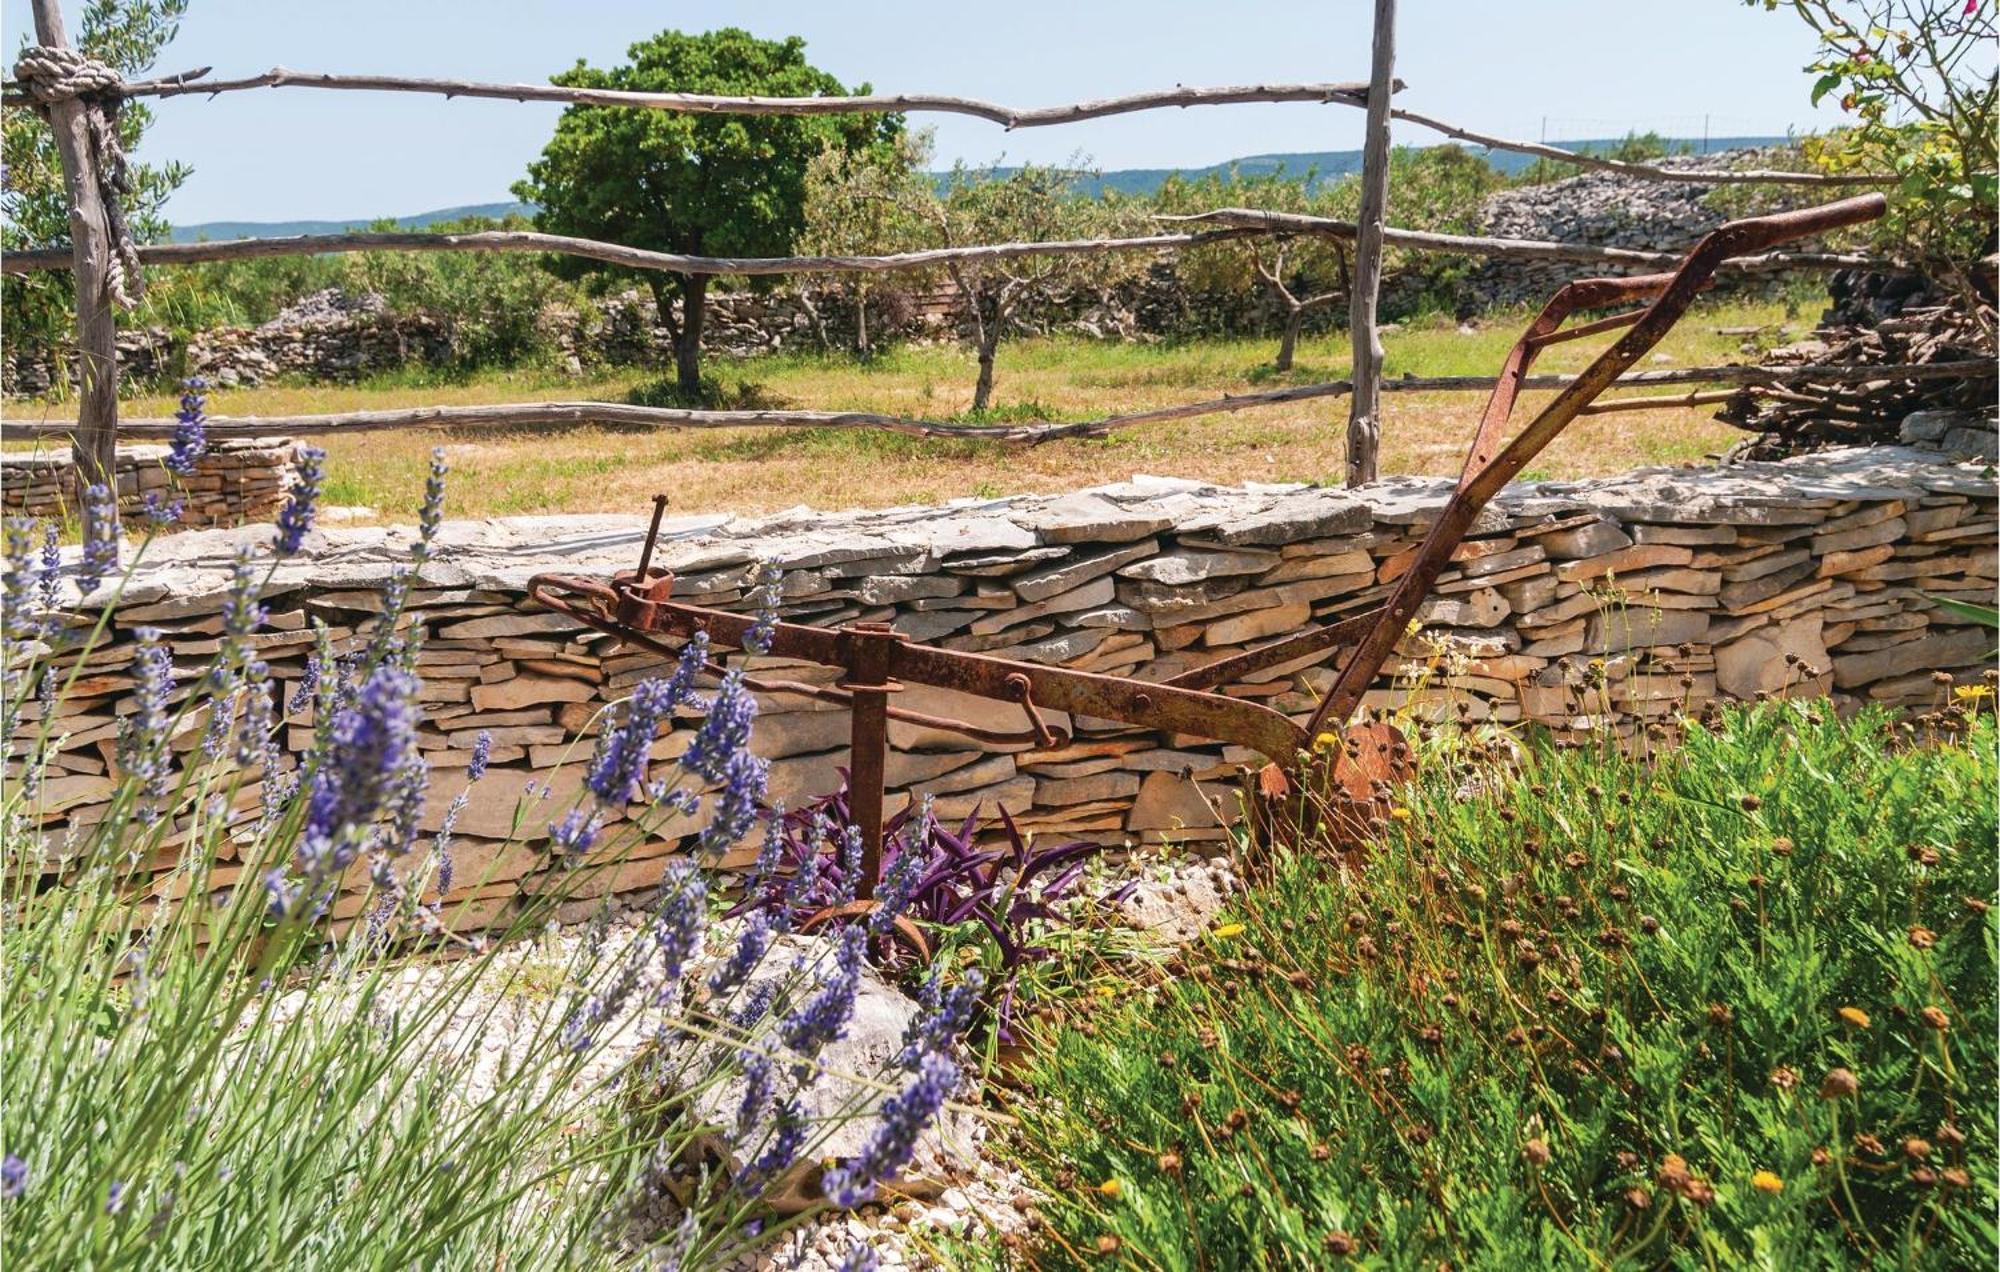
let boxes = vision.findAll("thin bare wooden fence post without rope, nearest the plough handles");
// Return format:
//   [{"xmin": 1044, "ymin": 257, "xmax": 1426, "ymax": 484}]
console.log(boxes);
[{"xmin": 1348, "ymin": 0, "xmax": 1396, "ymax": 486}]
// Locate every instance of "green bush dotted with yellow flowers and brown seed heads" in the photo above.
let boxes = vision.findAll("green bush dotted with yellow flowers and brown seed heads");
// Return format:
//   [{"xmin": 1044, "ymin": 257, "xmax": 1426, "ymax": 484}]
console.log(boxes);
[{"xmin": 992, "ymin": 704, "xmax": 2000, "ymax": 1268}]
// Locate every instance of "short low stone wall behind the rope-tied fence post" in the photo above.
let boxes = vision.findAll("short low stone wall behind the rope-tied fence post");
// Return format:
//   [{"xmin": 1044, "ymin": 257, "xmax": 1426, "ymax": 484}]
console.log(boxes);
[{"xmin": 0, "ymin": 438, "xmax": 298, "ymax": 528}]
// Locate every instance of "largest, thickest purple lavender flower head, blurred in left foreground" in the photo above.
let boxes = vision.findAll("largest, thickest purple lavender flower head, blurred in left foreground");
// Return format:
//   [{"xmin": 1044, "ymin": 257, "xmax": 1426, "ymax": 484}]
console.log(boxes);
[{"xmin": 298, "ymin": 666, "xmax": 418, "ymax": 884}]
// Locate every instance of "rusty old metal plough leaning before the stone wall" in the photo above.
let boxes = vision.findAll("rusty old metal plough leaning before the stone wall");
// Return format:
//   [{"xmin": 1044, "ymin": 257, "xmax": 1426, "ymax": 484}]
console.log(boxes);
[{"xmin": 528, "ymin": 194, "xmax": 1886, "ymax": 896}]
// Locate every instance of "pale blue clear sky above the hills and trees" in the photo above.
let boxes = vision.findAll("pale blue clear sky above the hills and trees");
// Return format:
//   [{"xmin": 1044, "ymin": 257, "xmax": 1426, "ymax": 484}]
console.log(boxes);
[{"xmin": 0, "ymin": 0, "xmax": 1838, "ymax": 224}]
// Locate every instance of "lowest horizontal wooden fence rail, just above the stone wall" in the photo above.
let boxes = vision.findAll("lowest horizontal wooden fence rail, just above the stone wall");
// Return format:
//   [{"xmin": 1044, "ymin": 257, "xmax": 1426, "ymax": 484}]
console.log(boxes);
[{"xmin": 8, "ymin": 360, "xmax": 1994, "ymax": 442}]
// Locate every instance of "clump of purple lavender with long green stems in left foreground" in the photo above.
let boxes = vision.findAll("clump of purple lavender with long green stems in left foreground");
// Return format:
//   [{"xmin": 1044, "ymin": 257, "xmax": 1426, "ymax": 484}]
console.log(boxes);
[{"xmin": 0, "ymin": 454, "xmax": 964, "ymax": 1268}]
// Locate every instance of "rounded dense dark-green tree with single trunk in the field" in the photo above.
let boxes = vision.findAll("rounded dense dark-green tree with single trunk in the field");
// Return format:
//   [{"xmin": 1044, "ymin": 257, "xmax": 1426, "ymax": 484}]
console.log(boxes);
[{"xmin": 514, "ymin": 28, "xmax": 902, "ymax": 400}]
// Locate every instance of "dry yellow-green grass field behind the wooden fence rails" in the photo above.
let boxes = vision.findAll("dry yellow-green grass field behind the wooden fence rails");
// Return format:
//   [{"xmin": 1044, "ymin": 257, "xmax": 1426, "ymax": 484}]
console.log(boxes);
[{"xmin": 8, "ymin": 302, "xmax": 1816, "ymax": 520}]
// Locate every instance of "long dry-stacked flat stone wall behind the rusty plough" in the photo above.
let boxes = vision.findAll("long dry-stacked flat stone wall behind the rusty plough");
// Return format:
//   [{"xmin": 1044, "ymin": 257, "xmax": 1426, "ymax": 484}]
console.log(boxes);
[{"xmin": 11, "ymin": 448, "xmax": 1996, "ymax": 936}]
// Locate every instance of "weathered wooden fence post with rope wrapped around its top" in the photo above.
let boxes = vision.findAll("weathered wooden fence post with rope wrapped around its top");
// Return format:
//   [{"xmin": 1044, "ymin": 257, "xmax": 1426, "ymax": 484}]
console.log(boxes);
[{"xmin": 34, "ymin": 0, "xmax": 118, "ymax": 534}]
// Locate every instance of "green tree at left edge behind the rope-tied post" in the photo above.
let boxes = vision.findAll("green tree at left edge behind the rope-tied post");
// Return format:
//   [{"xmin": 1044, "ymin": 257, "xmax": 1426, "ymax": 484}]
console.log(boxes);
[{"xmin": 0, "ymin": 0, "xmax": 192, "ymax": 368}]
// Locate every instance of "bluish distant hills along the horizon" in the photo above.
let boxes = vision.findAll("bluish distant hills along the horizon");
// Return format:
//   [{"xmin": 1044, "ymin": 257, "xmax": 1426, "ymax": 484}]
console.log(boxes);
[{"xmin": 174, "ymin": 136, "xmax": 1788, "ymax": 242}]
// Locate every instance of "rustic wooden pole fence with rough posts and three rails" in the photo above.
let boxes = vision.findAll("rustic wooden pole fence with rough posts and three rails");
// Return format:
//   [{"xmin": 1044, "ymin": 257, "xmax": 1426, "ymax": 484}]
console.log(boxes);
[{"xmin": 11, "ymin": 0, "xmax": 1920, "ymax": 540}]
